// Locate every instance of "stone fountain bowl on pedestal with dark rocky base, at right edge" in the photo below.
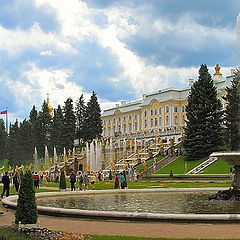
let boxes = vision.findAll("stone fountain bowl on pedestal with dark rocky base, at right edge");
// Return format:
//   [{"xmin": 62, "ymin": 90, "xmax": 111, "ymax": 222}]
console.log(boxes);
[{"xmin": 209, "ymin": 152, "xmax": 240, "ymax": 200}]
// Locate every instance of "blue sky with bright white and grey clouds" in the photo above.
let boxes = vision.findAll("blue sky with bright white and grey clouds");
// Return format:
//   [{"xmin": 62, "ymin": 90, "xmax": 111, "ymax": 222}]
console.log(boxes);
[{"xmin": 0, "ymin": 0, "xmax": 240, "ymax": 122}]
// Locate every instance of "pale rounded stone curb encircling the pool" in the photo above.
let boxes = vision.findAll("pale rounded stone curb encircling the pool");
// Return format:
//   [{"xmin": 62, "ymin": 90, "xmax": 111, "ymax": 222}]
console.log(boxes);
[{"xmin": 2, "ymin": 188, "xmax": 240, "ymax": 222}]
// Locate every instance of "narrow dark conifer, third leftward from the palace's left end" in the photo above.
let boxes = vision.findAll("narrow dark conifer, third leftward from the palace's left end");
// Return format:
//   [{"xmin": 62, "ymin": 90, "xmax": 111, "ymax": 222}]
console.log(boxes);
[{"xmin": 63, "ymin": 98, "xmax": 76, "ymax": 149}]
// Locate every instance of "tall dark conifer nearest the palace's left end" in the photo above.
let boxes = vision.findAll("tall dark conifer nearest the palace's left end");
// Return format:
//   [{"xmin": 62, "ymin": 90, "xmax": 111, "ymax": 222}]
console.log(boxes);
[{"xmin": 83, "ymin": 92, "xmax": 102, "ymax": 141}]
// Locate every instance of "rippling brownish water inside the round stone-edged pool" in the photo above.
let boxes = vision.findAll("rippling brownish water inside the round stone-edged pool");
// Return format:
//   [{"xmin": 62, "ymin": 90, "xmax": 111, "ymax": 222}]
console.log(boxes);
[{"xmin": 37, "ymin": 191, "xmax": 240, "ymax": 214}]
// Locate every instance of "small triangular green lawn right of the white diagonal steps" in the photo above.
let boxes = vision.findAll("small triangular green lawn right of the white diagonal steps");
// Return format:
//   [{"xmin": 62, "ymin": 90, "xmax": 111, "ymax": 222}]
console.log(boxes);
[{"xmin": 202, "ymin": 158, "xmax": 232, "ymax": 174}]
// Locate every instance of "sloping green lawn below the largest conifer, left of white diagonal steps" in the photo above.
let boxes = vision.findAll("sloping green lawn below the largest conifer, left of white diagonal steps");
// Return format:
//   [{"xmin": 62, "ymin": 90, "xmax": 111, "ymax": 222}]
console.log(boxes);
[{"xmin": 156, "ymin": 156, "xmax": 206, "ymax": 174}]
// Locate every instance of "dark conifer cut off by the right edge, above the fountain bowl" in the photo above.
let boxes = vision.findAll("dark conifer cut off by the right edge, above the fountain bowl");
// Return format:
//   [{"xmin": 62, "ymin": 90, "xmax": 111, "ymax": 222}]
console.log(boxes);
[{"xmin": 224, "ymin": 69, "xmax": 240, "ymax": 151}]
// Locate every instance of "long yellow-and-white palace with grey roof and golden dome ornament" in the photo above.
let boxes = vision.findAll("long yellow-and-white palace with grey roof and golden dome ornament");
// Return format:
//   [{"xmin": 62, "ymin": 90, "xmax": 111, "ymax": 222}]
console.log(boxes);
[{"xmin": 102, "ymin": 65, "xmax": 233, "ymax": 141}]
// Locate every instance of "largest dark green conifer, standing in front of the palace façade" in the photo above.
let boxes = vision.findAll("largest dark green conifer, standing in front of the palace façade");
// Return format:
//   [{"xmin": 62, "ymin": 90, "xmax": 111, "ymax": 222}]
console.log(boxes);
[{"xmin": 183, "ymin": 65, "xmax": 223, "ymax": 160}]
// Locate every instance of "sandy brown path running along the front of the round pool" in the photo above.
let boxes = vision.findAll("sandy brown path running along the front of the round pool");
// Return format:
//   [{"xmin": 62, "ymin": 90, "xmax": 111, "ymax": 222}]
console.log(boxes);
[{"xmin": 0, "ymin": 204, "xmax": 240, "ymax": 239}]
